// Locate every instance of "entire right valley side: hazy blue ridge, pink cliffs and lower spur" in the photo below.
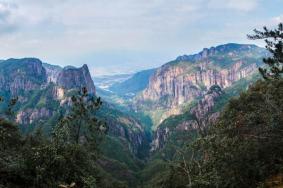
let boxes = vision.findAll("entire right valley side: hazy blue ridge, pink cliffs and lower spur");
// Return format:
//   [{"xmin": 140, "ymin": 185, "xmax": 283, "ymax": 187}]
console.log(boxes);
[{"xmin": 92, "ymin": 43, "xmax": 269, "ymax": 185}]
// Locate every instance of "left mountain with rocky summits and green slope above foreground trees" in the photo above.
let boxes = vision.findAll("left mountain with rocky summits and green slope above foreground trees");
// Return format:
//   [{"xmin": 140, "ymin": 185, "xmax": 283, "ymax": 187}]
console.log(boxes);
[{"xmin": 0, "ymin": 58, "xmax": 95, "ymax": 125}]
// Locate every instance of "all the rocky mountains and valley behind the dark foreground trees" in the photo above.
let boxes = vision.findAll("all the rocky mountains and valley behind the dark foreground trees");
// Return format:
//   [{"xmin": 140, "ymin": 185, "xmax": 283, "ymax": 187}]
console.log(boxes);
[{"xmin": 0, "ymin": 43, "xmax": 268, "ymax": 187}]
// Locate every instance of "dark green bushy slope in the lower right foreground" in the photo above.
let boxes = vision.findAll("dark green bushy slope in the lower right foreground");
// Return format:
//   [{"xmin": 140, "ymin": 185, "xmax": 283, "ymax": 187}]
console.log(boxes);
[{"xmin": 163, "ymin": 79, "xmax": 283, "ymax": 187}]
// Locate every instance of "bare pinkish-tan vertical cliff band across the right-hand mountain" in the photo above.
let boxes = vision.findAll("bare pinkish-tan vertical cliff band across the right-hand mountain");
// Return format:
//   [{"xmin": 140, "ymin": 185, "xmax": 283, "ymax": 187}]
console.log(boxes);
[{"xmin": 140, "ymin": 61, "xmax": 257, "ymax": 107}]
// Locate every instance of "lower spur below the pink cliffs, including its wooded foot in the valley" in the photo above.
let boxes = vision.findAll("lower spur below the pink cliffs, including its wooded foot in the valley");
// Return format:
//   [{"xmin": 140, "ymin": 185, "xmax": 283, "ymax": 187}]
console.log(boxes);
[{"xmin": 140, "ymin": 73, "xmax": 260, "ymax": 188}]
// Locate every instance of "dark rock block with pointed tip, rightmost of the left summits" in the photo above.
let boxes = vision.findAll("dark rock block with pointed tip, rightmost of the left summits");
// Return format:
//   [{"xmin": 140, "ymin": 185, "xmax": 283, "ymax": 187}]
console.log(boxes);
[{"xmin": 57, "ymin": 65, "xmax": 95, "ymax": 94}]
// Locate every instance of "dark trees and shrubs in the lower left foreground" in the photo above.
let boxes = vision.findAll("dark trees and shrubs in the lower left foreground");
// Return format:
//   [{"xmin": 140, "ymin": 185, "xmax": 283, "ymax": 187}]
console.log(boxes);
[{"xmin": 0, "ymin": 89, "xmax": 114, "ymax": 188}]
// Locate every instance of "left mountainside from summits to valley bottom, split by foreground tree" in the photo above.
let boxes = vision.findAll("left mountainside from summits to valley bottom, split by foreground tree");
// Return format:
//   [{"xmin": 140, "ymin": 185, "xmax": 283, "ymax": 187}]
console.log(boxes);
[{"xmin": 0, "ymin": 58, "xmax": 149, "ymax": 185}]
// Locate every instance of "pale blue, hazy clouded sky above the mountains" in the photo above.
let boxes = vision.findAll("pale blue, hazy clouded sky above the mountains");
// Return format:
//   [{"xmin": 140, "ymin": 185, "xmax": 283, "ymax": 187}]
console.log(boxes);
[{"xmin": 0, "ymin": 0, "xmax": 283, "ymax": 76}]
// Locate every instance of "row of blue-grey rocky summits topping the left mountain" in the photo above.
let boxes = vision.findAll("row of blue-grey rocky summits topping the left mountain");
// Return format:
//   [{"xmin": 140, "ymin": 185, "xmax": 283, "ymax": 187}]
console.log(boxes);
[{"xmin": 0, "ymin": 58, "xmax": 95, "ymax": 96}]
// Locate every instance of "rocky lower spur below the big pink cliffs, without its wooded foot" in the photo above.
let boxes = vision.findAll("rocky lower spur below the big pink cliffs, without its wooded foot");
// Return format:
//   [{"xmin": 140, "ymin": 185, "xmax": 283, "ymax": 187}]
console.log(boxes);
[{"xmin": 151, "ymin": 73, "xmax": 260, "ymax": 154}]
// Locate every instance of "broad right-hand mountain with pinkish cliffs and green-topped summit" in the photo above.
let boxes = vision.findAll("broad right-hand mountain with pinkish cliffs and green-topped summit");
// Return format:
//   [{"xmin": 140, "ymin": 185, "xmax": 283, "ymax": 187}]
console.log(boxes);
[{"xmin": 135, "ymin": 44, "xmax": 267, "ymax": 125}]
